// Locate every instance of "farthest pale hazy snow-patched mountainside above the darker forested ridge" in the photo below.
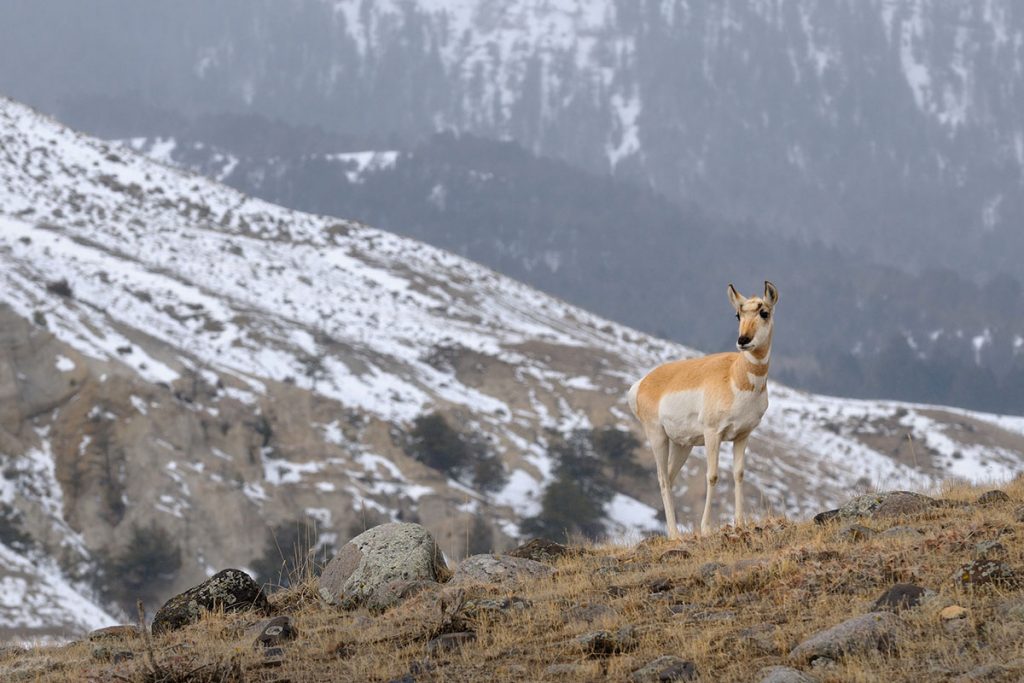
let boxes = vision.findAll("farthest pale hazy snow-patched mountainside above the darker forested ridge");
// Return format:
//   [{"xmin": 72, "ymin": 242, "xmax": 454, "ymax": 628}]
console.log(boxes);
[{"xmin": 0, "ymin": 0, "xmax": 1024, "ymax": 280}]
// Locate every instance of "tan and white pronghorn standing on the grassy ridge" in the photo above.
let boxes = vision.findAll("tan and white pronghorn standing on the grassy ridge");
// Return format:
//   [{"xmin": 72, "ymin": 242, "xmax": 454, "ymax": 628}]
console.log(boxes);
[{"xmin": 629, "ymin": 281, "xmax": 778, "ymax": 539}]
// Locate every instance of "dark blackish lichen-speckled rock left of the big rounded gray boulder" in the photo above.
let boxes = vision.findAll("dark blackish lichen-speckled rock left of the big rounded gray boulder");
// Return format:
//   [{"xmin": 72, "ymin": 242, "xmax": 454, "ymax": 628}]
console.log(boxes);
[{"xmin": 152, "ymin": 569, "xmax": 270, "ymax": 635}]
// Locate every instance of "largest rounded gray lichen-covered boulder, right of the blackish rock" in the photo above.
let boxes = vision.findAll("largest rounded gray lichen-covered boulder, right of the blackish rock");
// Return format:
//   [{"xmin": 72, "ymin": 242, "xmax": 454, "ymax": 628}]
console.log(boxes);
[{"xmin": 319, "ymin": 522, "xmax": 450, "ymax": 611}]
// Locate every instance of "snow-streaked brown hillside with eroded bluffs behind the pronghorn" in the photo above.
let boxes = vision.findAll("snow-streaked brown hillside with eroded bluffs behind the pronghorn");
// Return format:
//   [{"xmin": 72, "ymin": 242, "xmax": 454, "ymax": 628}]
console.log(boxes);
[{"xmin": 0, "ymin": 99, "xmax": 1024, "ymax": 633}]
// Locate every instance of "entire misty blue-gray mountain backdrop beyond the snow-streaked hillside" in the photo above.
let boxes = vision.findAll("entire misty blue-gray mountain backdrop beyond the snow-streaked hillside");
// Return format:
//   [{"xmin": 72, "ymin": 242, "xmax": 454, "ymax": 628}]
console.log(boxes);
[{"xmin": 0, "ymin": 0, "xmax": 1024, "ymax": 414}]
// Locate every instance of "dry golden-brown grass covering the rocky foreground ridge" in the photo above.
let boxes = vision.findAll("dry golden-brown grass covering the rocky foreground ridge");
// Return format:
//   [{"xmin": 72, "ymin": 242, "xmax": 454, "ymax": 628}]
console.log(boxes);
[{"xmin": 9, "ymin": 481, "xmax": 1024, "ymax": 683}]
